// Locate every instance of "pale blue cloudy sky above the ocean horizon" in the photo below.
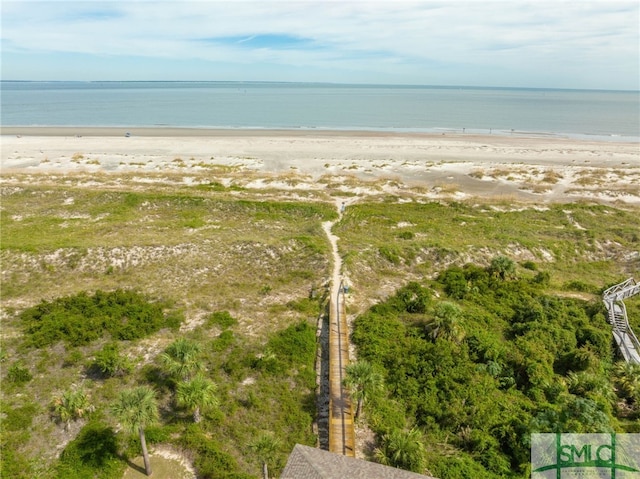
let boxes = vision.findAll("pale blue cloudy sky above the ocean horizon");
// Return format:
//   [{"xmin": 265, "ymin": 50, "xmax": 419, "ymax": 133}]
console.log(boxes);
[{"xmin": 0, "ymin": 0, "xmax": 640, "ymax": 90}]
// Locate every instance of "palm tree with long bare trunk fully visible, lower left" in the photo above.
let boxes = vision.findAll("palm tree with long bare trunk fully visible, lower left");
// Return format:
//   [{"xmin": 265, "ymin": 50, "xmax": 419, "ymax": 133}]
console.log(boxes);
[{"xmin": 111, "ymin": 386, "xmax": 158, "ymax": 476}]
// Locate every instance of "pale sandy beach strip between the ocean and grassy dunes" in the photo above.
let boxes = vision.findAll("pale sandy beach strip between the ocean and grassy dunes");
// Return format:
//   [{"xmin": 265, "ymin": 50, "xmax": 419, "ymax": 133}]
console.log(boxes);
[{"xmin": 0, "ymin": 127, "xmax": 640, "ymax": 204}]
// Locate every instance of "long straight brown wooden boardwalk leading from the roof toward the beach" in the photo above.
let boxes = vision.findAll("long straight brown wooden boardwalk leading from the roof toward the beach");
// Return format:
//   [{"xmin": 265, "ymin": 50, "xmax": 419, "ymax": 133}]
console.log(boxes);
[{"xmin": 329, "ymin": 284, "xmax": 355, "ymax": 457}]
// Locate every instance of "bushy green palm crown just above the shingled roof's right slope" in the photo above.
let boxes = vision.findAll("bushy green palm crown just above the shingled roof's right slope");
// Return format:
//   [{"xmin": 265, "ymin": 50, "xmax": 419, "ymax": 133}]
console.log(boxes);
[{"xmin": 376, "ymin": 428, "xmax": 427, "ymax": 473}]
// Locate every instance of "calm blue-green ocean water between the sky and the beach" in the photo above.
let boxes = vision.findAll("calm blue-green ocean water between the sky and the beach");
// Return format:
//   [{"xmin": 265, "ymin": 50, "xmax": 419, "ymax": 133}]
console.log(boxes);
[{"xmin": 0, "ymin": 81, "xmax": 640, "ymax": 141}]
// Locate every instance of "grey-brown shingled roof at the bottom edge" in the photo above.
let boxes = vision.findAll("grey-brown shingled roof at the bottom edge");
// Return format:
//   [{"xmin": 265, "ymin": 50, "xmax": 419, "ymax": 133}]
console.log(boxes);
[{"xmin": 280, "ymin": 444, "xmax": 433, "ymax": 479}]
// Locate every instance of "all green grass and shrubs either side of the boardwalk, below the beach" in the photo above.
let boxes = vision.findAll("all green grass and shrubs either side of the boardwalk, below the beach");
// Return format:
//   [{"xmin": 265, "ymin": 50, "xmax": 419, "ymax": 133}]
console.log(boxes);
[{"xmin": 0, "ymin": 177, "xmax": 640, "ymax": 479}]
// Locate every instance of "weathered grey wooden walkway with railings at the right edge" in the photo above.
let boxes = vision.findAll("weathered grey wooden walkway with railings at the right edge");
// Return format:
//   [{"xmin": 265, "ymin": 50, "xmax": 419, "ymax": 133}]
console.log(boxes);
[{"xmin": 602, "ymin": 278, "xmax": 640, "ymax": 364}]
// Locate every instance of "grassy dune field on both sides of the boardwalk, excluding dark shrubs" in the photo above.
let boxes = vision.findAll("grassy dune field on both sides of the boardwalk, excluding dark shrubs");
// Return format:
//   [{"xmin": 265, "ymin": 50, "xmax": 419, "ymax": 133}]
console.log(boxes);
[{"xmin": 0, "ymin": 172, "xmax": 640, "ymax": 478}]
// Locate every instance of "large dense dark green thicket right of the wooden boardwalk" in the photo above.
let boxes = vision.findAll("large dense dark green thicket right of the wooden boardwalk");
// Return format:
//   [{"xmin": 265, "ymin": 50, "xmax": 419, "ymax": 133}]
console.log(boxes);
[{"xmin": 352, "ymin": 260, "xmax": 640, "ymax": 479}]
